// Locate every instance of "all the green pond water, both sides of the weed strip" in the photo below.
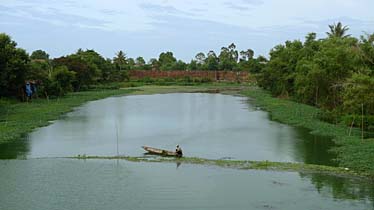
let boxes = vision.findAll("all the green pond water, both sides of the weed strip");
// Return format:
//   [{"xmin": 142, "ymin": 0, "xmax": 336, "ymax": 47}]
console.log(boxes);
[{"xmin": 0, "ymin": 93, "xmax": 374, "ymax": 210}]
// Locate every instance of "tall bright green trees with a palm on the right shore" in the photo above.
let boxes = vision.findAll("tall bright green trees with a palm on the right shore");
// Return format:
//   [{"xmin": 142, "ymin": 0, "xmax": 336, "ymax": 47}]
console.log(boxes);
[{"xmin": 257, "ymin": 22, "xmax": 374, "ymax": 131}]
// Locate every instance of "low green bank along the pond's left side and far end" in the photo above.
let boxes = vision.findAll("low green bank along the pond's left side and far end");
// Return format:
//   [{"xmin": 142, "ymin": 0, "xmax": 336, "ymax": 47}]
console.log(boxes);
[{"xmin": 0, "ymin": 83, "xmax": 248, "ymax": 144}]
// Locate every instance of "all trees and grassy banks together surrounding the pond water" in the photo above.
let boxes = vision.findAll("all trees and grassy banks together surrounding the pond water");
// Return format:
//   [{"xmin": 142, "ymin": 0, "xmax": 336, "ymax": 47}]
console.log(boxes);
[{"xmin": 0, "ymin": 23, "xmax": 374, "ymax": 177}]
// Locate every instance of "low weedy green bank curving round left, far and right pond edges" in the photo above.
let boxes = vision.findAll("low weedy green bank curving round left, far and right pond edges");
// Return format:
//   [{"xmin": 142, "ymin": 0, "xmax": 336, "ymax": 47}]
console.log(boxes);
[{"xmin": 0, "ymin": 83, "xmax": 374, "ymax": 177}]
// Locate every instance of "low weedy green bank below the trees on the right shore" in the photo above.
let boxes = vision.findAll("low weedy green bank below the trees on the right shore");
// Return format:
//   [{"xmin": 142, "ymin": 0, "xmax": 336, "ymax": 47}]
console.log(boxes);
[{"xmin": 241, "ymin": 87, "xmax": 374, "ymax": 176}]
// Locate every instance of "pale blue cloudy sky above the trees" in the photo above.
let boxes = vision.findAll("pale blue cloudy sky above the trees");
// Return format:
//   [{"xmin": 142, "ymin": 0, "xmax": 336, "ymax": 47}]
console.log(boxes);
[{"xmin": 0, "ymin": 0, "xmax": 374, "ymax": 62}]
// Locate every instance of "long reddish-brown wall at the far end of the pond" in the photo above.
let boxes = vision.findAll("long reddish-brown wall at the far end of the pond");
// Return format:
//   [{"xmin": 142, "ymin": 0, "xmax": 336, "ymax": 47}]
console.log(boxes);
[{"xmin": 129, "ymin": 70, "xmax": 250, "ymax": 82}]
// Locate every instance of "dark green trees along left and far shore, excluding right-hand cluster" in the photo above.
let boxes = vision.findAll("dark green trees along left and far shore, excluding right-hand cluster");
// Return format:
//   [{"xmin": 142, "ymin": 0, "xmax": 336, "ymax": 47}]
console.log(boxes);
[{"xmin": 0, "ymin": 33, "xmax": 266, "ymax": 97}]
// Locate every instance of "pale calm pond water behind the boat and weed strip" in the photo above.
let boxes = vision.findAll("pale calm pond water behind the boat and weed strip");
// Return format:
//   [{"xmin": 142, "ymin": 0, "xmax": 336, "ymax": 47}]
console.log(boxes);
[{"xmin": 2, "ymin": 93, "xmax": 334, "ymax": 165}]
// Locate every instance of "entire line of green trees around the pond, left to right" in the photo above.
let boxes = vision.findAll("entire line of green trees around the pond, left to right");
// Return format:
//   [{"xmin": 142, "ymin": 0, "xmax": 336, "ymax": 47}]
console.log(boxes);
[{"xmin": 0, "ymin": 23, "xmax": 374, "ymax": 130}]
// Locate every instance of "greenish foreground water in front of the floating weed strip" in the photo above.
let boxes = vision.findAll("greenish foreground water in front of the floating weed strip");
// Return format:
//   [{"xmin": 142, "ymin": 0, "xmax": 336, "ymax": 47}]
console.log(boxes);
[{"xmin": 0, "ymin": 159, "xmax": 373, "ymax": 210}]
